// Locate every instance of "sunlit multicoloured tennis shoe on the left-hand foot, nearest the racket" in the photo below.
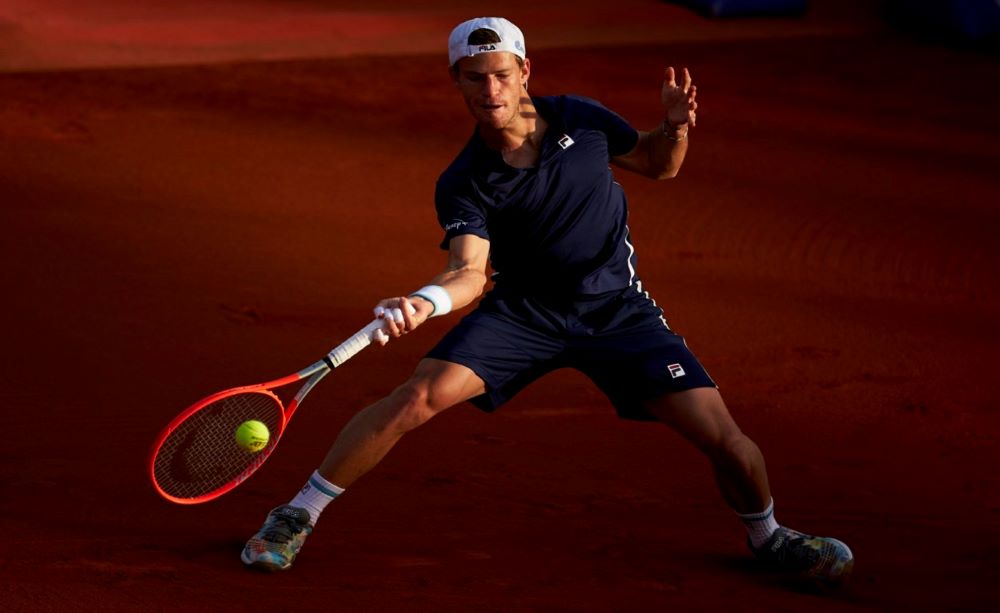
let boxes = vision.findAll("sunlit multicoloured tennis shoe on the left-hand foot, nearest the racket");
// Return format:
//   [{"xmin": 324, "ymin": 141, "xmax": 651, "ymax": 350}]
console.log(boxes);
[{"xmin": 240, "ymin": 504, "xmax": 312, "ymax": 571}]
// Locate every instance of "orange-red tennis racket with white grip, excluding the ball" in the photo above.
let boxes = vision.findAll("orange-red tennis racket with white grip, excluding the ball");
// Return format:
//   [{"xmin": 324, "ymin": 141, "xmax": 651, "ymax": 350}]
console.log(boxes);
[{"xmin": 149, "ymin": 314, "xmax": 398, "ymax": 504}]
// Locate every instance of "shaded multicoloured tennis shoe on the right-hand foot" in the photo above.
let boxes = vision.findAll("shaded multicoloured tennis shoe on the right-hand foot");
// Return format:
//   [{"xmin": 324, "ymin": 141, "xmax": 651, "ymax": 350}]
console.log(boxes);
[{"xmin": 748, "ymin": 528, "xmax": 854, "ymax": 588}]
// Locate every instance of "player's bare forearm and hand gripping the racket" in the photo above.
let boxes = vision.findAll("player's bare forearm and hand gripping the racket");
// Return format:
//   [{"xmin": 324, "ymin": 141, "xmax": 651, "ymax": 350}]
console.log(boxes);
[{"xmin": 378, "ymin": 234, "xmax": 490, "ymax": 337}]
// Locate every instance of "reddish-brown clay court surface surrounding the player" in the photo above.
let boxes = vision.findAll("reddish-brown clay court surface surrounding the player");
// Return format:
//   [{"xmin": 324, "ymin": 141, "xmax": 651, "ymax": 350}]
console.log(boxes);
[{"xmin": 0, "ymin": 0, "xmax": 1000, "ymax": 611}]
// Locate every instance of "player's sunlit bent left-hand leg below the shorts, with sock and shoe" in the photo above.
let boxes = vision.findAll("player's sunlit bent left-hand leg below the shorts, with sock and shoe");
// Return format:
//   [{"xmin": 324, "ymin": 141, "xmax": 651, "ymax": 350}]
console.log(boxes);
[{"xmin": 240, "ymin": 358, "xmax": 486, "ymax": 571}]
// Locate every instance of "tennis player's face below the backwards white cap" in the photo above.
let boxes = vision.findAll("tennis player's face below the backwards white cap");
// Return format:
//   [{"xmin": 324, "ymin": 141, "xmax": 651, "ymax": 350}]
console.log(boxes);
[{"xmin": 453, "ymin": 51, "xmax": 530, "ymax": 130}]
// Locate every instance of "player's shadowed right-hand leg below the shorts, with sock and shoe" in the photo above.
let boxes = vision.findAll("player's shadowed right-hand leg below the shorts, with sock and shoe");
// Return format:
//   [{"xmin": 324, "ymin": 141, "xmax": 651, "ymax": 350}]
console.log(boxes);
[{"xmin": 646, "ymin": 387, "xmax": 854, "ymax": 586}]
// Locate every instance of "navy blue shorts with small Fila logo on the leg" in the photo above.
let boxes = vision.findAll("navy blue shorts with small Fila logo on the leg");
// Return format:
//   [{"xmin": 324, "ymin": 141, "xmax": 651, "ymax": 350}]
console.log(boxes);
[{"xmin": 427, "ymin": 285, "xmax": 716, "ymax": 420}]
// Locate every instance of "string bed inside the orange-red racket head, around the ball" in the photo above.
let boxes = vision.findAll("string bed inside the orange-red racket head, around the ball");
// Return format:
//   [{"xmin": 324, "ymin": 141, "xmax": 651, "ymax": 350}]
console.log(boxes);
[{"xmin": 153, "ymin": 391, "xmax": 282, "ymax": 499}]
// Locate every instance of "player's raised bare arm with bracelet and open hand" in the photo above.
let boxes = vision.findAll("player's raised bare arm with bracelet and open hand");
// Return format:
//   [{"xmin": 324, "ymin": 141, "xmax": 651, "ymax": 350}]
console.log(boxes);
[{"xmin": 611, "ymin": 67, "xmax": 698, "ymax": 179}]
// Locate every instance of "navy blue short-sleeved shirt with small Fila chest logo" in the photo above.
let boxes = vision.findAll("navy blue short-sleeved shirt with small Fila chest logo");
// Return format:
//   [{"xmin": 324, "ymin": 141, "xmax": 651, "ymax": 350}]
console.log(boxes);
[{"xmin": 435, "ymin": 96, "xmax": 638, "ymax": 296}]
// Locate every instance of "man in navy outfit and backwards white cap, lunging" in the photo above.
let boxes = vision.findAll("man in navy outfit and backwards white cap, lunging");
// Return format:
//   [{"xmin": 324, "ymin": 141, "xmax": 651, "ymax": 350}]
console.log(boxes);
[{"xmin": 242, "ymin": 18, "xmax": 853, "ymax": 584}]
